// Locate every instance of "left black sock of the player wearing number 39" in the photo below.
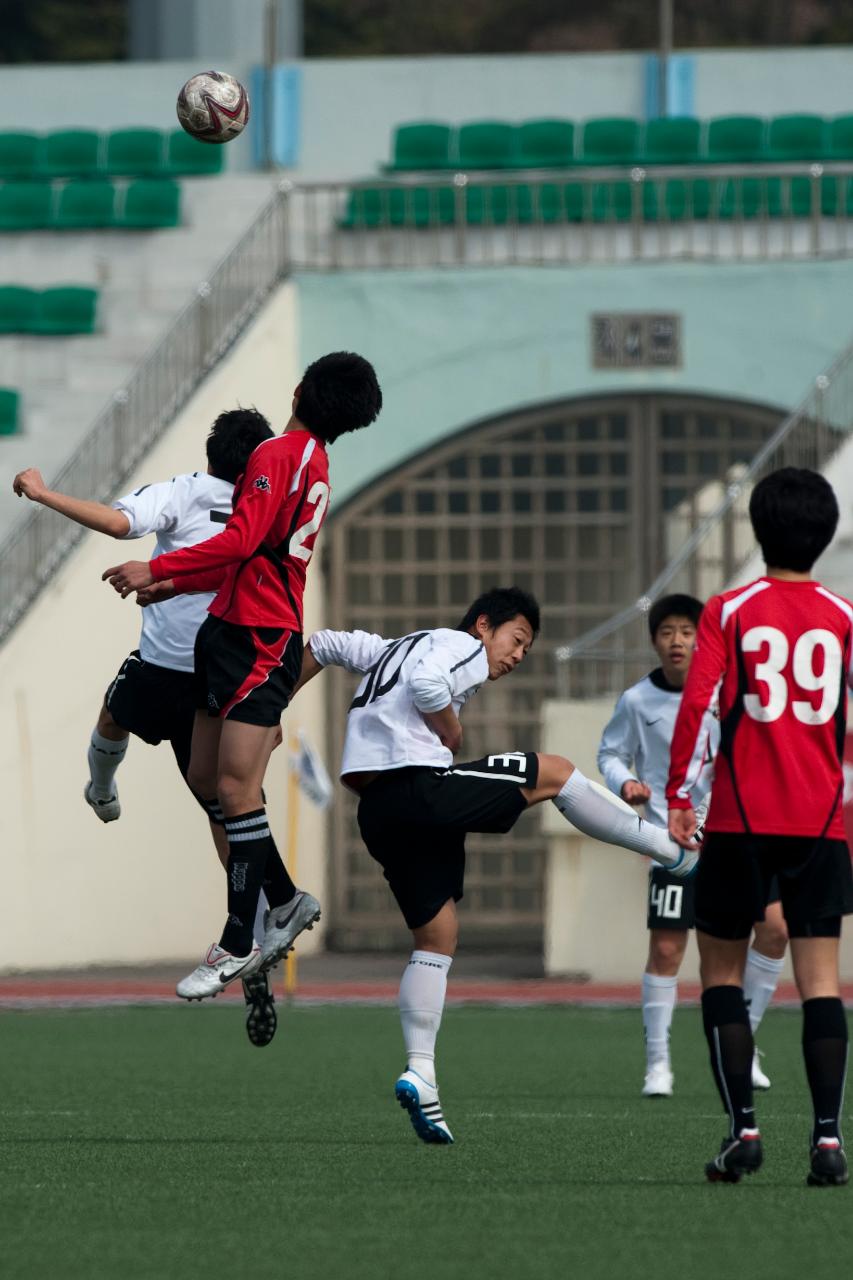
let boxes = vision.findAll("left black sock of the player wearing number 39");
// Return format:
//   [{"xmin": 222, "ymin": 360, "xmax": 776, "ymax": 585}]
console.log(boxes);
[{"xmin": 702, "ymin": 987, "xmax": 756, "ymax": 1138}]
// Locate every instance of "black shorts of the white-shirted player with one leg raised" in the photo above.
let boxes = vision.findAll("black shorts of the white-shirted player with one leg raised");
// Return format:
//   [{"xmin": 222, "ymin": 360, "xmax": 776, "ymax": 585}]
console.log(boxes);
[{"xmin": 359, "ymin": 751, "xmax": 539, "ymax": 929}]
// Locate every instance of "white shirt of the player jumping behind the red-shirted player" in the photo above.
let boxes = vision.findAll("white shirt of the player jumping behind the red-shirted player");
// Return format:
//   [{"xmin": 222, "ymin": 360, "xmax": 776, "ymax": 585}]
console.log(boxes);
[{"xmin": 113, "ymin": 471, "xmax": 234, "ymax": 672}]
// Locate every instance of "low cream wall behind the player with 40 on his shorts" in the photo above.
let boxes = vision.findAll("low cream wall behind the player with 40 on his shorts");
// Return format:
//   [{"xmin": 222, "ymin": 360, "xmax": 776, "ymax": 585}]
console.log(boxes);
[{"xmin": 542, "ymin": 701, "xmax": 853, "ymax": 982}]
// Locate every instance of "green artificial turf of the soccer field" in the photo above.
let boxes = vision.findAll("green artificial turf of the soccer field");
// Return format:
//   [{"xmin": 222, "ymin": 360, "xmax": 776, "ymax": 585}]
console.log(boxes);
[{"xmin": 0, "ymin": 1006, "xmax": 853, "ymax": 1280}]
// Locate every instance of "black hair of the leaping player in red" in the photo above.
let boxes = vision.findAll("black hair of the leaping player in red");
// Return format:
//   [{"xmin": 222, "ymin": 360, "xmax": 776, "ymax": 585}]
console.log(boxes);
[{"xmin": 296, "ymin": 351, "xmax": 382, "ymax": 444}]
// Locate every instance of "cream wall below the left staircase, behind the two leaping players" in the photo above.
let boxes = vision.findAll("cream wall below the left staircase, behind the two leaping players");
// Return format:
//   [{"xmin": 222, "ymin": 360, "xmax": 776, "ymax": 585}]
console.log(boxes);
[{"xmin": 0, "ymin": 277, "xmax": 325, "ymax": 977}]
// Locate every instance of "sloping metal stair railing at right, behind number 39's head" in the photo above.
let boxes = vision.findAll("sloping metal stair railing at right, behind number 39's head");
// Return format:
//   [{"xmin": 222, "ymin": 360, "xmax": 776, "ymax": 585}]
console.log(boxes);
[{"xmin": 553, "ymin": 343, "xmax": 853, "ymax": 698}]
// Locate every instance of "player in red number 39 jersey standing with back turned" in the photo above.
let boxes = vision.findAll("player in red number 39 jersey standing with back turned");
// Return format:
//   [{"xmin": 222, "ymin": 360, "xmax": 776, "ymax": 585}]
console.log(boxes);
[{"xmin": 666, "ymin": 467, "xmax": 853, "ymax": 1187}]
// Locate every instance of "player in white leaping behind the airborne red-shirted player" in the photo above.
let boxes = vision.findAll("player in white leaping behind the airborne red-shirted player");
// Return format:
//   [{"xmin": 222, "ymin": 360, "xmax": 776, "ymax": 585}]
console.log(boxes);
[{"xmin": 13, "ymin": 408, "xmax": 275, "ymax": 1047}]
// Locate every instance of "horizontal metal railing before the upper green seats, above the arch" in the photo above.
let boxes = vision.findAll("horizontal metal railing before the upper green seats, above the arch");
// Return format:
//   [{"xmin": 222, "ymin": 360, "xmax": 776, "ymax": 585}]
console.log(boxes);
[{"xmin": 284, "ymin": 163, "xmax": 853, "ymax": 270}]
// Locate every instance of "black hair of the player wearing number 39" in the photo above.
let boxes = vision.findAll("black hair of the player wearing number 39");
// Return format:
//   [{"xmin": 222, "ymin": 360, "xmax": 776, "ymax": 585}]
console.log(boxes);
[{"xmin": 749, "ymin": 467, "xmax": 838, "ymax": 573}]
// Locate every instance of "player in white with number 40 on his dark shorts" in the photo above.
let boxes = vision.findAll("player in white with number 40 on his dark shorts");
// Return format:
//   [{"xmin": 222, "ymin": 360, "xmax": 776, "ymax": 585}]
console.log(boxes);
[{"xmin": 598, "ymin": 595, "xmax": 788, "ymax": 1097}]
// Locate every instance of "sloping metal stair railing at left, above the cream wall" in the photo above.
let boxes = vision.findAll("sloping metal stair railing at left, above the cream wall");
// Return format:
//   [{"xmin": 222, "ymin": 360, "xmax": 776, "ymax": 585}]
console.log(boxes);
[{"xmin": 0, "ymin": 189, "xmax": 288, "ymax": 641}]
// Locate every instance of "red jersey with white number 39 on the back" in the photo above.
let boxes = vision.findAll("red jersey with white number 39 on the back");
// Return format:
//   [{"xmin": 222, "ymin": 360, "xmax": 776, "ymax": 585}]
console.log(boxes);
[{"xmin": 666, "ymin": 577, "xmax": 853, "ymax": 840}]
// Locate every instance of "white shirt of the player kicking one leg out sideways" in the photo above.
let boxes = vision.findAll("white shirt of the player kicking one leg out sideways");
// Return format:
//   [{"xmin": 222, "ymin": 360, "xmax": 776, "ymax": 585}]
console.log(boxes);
[{"xmin": 310, "ymin": 627, "xmax": 489, "ymax": 774}]
